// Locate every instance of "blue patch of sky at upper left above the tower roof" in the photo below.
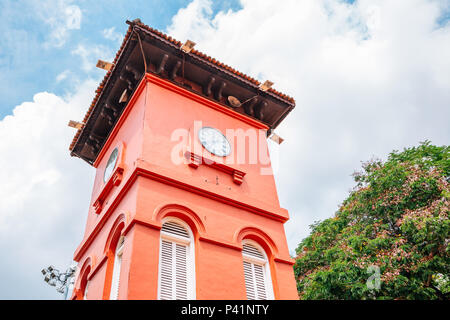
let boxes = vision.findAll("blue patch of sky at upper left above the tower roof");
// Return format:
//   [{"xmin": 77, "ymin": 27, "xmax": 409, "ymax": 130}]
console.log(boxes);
[{"xmin": 0, "ymin": 0, "xmax": 240, "ymax": 119}]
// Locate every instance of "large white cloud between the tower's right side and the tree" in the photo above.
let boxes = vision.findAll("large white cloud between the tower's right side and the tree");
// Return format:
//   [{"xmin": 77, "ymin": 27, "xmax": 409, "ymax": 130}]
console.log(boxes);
[{"xmin": 167, "ymin": 0, "xmax": 450, "ymax": 251}]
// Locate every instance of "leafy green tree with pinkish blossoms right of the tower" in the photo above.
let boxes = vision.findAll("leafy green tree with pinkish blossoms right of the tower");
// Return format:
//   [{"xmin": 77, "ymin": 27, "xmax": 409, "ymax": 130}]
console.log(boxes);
[{"xmin": 294, "ymin": 141, "xmax": 450, "ymax": 299}]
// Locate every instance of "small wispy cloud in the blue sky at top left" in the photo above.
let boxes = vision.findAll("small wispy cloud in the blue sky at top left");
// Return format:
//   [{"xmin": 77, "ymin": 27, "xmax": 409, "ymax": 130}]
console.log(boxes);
[{"xmin": 35, "ymin": 0, "xmax": 83, "ymax": 47}]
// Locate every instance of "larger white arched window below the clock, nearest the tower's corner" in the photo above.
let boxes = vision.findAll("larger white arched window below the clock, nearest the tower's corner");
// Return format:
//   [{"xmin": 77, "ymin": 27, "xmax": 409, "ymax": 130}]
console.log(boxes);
[{"xmin": 158, "ymin": 218, "xmax": 195, "ymax": 300}]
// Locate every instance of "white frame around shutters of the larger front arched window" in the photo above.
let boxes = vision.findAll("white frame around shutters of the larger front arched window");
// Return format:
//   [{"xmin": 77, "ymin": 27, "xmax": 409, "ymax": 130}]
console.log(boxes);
[{"xmin": 158, "ymin": 217, "xmax": 196, "ymax": 300}]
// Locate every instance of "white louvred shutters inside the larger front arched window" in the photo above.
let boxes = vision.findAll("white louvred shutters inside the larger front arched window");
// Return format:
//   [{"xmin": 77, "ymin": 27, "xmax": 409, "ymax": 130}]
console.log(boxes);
[{"xmin": 159, "ymin": 221, "xmax": 189, "ymax": 300}]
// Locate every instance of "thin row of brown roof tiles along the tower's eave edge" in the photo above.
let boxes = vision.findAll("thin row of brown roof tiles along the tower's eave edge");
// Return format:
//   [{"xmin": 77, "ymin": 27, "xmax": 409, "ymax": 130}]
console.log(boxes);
[{"xmin": 69, "ymin": 20, "xmax": 295, "ymax": 151}]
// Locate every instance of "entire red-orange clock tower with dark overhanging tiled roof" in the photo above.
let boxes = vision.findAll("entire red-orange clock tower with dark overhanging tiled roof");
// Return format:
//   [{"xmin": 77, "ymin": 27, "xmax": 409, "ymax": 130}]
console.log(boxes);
[{"xmin": 70, "ymin": 19, "xmax": 298, "ymax": 299}]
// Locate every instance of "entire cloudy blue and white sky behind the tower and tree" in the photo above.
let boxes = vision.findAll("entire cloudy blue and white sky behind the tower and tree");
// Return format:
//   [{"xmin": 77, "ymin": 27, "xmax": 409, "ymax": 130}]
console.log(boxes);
[{"xmin": 0, "ymin": 0, "xmax": 450, "ymax": 299}]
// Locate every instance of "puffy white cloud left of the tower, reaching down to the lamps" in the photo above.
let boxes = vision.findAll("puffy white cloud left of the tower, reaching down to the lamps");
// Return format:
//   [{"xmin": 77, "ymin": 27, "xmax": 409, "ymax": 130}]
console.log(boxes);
[{"xmin": 0, "ymin": 80, "xmax": 97, "ymax": 299}]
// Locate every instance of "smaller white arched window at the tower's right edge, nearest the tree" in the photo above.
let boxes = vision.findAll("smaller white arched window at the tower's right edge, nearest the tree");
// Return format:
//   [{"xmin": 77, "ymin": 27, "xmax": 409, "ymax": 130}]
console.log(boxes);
[{"xmin": 242, "ymin": 240, "xmax": 273, "ymax": 300}]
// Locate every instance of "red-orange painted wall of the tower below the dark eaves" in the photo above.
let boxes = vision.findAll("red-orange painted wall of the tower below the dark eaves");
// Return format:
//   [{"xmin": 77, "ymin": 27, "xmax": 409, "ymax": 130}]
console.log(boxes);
[{"xmin": 74, "ymin": 74, "xmax": 297, "ymax": 299}]
